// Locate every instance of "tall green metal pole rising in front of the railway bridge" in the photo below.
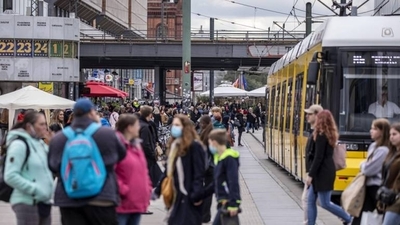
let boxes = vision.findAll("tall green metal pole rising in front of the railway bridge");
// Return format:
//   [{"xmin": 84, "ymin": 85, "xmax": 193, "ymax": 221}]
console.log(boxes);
[{"xmin": 182, "ymin": 0, "xmax": 192, "ymax": 106}]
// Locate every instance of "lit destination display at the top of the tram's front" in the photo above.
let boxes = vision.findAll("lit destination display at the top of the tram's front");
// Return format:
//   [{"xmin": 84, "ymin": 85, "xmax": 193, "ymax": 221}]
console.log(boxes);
[{"xmin": 343, "ymin": 52, "xmax": 400, "ymax": 67}]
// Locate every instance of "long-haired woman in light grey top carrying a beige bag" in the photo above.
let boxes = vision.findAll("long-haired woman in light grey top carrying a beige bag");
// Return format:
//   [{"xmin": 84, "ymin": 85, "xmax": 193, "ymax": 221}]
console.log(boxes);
[{"xmin": 352, "ymin": 118, "xmax": 390, "ymax": 225}]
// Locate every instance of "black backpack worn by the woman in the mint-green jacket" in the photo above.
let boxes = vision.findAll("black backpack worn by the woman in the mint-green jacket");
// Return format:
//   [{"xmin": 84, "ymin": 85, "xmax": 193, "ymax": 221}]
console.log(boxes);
[{"xmin": 0, "ymin": 136, "xmax": 30, "ymax": 202}]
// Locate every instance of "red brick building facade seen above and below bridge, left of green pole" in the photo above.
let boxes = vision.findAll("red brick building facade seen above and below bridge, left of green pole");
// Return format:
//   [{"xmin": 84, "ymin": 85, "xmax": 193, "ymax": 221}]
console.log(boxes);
[{"xmin": 147, "ymin": 0, "xmax": 182, "ymax": 98}]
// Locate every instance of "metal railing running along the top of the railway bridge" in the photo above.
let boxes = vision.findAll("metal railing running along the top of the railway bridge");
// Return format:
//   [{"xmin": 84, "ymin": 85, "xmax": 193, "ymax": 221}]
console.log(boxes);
[{"xmin": 81, "ymin": 29, "xmax": 305, "ymax": 44}]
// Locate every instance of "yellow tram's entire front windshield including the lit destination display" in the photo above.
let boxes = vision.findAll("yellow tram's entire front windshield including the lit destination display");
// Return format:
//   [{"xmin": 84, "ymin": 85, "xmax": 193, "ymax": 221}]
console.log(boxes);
[{"xmin": 339, "ymin": 52, "xmax": 400, "ymax": 133}]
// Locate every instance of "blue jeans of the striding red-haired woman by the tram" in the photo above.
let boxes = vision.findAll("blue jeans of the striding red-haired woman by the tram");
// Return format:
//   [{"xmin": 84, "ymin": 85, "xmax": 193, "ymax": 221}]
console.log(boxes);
[{"xmin": 307, "ymin": 185, "xmax": 351, "ymax": 225}]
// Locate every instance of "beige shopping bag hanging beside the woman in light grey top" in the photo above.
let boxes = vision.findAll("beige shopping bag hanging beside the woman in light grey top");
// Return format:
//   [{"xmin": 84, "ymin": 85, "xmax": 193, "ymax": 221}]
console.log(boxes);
[{"xmin": 340, "ymin": 173, "xmax": 366, "ymax": 217}]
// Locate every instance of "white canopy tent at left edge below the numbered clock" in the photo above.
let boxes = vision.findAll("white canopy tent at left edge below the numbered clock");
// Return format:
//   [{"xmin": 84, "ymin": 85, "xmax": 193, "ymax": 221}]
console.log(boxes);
[{"xmin": 0, "ymin": 86, "xmax": 75, "ymax": 129}]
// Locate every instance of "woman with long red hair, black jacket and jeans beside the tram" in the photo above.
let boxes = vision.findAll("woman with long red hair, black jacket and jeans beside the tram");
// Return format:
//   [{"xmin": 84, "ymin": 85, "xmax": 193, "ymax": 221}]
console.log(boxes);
[{"xmin": 306, "ymin": 110, "xmax": 352, "ymax": 225}]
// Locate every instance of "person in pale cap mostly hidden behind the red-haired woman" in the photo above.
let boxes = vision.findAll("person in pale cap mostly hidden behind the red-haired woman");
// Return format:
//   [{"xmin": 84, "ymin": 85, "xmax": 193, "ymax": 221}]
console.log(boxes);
[{"xmin": 301, "ymin": 105, "xmax": 323, "ymax": 224}]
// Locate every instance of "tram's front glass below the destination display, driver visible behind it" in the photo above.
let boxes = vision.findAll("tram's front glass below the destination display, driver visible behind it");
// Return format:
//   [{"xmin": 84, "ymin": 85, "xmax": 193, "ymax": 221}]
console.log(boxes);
[{"xmin": 339, "ymin": 67, "xmax": 400, "ymax": 133}]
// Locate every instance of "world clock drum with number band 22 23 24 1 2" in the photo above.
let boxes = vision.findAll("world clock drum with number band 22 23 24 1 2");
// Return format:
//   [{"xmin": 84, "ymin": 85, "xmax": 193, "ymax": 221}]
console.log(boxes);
[{"xmin": 0, "ymin": 14, "xmax": 80, "ymax": 82}]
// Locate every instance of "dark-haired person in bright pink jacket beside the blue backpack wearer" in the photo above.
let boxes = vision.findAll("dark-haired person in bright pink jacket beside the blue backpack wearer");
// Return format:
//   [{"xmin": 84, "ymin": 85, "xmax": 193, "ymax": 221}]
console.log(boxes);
[{"xmin": 115, "ymin": 114, "xmax": 152, "ymax": 225}]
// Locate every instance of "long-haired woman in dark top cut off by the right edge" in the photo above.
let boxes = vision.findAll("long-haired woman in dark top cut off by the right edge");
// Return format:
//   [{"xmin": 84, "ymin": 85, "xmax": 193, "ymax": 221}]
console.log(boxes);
[{"xmin": 378, "ymin": 123, "xmax": 400, "ymax": 225}]
